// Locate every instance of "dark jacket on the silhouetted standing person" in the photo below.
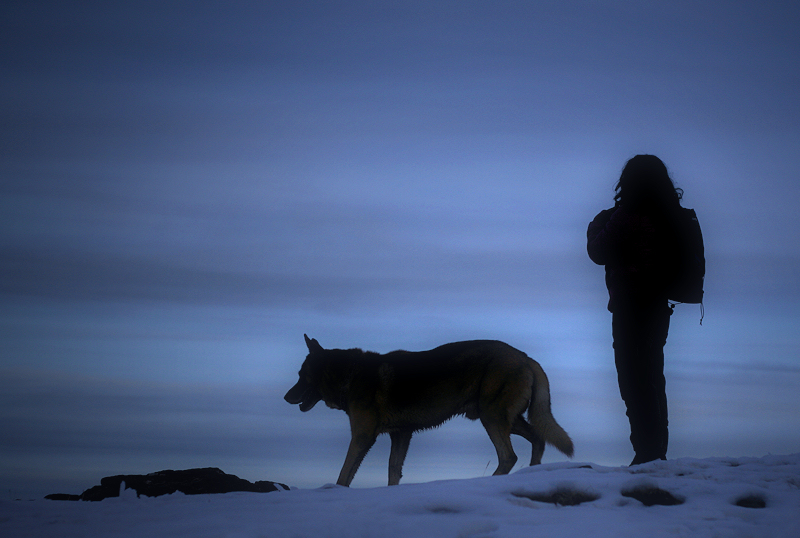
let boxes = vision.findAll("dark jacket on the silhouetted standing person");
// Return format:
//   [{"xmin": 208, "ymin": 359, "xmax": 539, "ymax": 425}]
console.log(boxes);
[{"xmin": 586, "ymin": 202, "xmax": 675, "ymax": 312}]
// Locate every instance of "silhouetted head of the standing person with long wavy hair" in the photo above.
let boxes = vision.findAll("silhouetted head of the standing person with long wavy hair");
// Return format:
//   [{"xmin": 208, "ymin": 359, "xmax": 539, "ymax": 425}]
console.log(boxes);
[{"xmin": 614, "ymin": 155, "xmax": 683, "ymax": 208}]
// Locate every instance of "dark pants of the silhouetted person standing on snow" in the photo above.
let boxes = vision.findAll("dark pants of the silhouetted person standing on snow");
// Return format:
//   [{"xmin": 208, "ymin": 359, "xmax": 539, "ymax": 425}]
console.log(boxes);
[{"xmin": 611, "ymin": 301, "xmax": 672, "ymax": 465}]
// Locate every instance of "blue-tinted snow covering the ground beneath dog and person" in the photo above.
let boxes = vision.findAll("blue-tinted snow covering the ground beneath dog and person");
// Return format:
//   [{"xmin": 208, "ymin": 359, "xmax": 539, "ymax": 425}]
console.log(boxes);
[{"xmin": 0, "ymin": 454, "xmax": 800, "ymax": 538}]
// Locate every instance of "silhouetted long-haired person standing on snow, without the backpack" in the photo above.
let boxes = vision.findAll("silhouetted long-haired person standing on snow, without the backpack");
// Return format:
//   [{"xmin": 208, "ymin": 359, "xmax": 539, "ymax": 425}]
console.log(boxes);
[{"xmin": 587, "ymin": 155, "xmax": 683, "ymax": 465}]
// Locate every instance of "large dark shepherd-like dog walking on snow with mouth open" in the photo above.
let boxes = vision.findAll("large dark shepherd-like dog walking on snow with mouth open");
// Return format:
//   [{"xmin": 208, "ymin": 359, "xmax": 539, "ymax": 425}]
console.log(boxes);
[{"xmin": 284, "ymin": 335, "xmax": 574, "ymax": 486}]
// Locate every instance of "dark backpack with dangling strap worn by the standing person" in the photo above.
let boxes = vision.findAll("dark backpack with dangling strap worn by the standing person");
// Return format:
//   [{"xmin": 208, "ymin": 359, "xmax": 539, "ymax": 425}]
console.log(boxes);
[{"xmin": 667, "ymin": 207, "xmax": 706, "ymax": 312}]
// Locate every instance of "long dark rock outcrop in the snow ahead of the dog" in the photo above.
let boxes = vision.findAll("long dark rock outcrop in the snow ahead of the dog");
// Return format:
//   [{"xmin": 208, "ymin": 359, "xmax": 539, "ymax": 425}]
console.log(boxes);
[{"xmin": 46, "ymin": 467, "xmax": 289, "ymax": 501}]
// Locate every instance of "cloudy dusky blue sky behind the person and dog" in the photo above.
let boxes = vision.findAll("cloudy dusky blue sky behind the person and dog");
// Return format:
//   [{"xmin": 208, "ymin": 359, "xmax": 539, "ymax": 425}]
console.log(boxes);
[{"xmin": 0, "ymin": 1, "xmax": 800, "ymax": 497}]
